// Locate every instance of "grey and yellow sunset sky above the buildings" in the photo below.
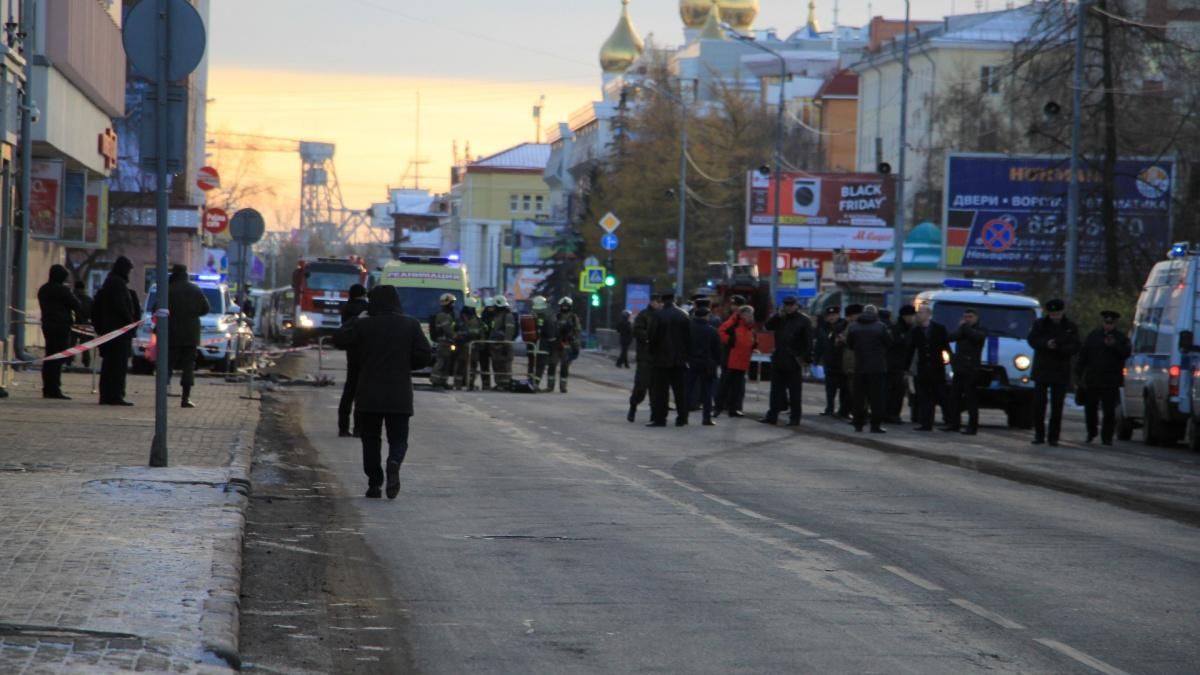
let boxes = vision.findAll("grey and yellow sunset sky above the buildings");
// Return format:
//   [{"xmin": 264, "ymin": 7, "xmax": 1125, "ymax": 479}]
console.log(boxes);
[{"xmin": 209, "ymin": 0, "xmax": 988, "ymax": 228}]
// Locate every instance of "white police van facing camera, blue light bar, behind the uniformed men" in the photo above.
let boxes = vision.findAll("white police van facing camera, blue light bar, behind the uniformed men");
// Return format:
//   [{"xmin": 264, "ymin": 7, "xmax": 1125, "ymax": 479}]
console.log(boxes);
[{"xmin": 913, "ymin": 279, "xmax": 1042, "ymax": 429}]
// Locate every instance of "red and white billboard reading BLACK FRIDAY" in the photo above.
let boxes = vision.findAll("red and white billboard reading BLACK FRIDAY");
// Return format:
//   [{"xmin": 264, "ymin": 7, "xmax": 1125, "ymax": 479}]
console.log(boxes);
[{"xmin": 746, "ymin": 172, "xmax": 895, "ymax": 251}]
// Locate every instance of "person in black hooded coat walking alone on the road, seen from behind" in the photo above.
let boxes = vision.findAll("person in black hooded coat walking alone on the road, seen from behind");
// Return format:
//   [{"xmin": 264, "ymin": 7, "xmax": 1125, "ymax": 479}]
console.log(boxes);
[{"xmin": 334, "ymin": 281, "xmax": 433, "ymax": 500}]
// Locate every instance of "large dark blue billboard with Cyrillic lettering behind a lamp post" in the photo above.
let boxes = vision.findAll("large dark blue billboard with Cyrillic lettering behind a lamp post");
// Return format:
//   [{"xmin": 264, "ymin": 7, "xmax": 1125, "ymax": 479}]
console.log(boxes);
[{"xmin": 943, "ymin": 155, "xmax": 1175, "ymax": 274}]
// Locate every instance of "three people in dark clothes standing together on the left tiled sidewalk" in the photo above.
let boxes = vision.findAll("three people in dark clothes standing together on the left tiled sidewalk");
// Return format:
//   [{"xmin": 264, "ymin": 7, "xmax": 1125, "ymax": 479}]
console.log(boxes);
[{"xmin": 37, "ymin": 256, "xmax": 209, "ymax": 408}]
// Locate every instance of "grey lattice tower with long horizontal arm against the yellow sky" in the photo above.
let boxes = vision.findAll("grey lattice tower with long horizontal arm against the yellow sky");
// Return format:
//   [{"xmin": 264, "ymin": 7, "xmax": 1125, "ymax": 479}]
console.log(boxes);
[{"xmin": 209, "ymin": 132, "xmax": 391, "ymax": 244}]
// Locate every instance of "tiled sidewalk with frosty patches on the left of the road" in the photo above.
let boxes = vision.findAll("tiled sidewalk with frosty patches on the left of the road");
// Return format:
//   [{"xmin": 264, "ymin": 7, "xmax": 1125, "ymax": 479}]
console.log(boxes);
[{"xmin": 0, "ymin": 371, "xmax": 259, "ymax": 673}]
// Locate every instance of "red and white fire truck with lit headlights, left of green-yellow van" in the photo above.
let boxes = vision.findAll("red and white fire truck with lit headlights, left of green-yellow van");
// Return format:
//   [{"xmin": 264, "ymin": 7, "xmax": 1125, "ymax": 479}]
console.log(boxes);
[{"xmin": 292, "ymin": 256, "xmax": 367, "ymax": 345}]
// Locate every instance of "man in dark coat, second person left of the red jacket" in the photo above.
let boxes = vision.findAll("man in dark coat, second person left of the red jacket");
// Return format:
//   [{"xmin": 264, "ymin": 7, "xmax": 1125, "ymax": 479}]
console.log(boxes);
[{"xmin": 647, "ymin": 293, "xmax": 691, "ymax": 426}]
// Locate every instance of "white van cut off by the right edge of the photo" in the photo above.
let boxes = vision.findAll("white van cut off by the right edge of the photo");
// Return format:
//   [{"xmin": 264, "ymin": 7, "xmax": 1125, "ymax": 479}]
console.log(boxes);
[{"xmin": 1117, "ymin": 243, "xmax": 1200, "ymax": 446}]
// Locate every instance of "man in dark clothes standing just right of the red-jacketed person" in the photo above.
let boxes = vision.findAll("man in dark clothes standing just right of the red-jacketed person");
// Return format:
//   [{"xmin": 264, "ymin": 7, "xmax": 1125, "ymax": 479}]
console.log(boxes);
[{"xmin": 758, "ymin": 295, "xmax": 812, "ymax": 426}]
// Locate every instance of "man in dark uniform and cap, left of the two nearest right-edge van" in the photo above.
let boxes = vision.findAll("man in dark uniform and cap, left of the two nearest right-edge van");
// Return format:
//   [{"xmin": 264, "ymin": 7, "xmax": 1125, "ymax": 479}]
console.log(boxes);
[{"xmin": 1028, "ymin": 299, "xmax": 1082, "ymax": 446}]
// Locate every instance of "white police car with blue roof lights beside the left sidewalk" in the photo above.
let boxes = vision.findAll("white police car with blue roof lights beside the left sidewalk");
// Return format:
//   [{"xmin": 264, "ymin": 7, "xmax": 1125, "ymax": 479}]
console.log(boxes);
[{"xmin": 132, "ymin": 274, "xmax": 254, "ymax": 372}]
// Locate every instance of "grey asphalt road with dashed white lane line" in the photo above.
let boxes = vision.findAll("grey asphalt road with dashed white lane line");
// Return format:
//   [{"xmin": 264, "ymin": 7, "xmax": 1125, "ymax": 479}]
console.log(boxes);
[{"xmin": 262, "ymin": 353, "xmax": 1200, "ymax": 674}]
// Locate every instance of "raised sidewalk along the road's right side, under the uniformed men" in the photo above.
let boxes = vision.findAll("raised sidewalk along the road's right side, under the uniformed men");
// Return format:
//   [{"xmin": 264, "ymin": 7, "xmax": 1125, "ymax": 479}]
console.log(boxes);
[{"xmin": 571, "ymin": 352, "xmax": 1200, "ymax": 525}]
